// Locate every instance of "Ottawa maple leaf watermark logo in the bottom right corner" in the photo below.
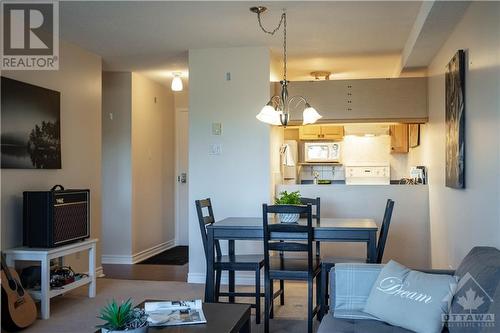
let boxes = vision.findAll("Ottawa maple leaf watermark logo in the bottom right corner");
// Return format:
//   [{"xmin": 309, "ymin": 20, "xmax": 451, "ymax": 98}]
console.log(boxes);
[{"xmin": 443, "ymin": 273, "xmax": 495, "ymax": 332}]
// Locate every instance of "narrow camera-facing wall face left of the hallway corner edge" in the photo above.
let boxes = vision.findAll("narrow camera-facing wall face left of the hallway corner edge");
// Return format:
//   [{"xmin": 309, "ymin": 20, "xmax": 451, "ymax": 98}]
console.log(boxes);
[{"xmin": 102, "ymin": 72, "xmax": 132, "ymax": 255}]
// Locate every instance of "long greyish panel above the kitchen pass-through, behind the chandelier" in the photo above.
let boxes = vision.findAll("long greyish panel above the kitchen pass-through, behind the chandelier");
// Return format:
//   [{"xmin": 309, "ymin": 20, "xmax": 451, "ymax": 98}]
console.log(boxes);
[{"xmin": 276, "ymin": 78, "xmax": 428, "ymax": 123}]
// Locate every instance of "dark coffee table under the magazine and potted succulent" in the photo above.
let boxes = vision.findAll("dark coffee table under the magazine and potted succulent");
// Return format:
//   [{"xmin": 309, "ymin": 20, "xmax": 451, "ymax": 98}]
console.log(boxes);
[{"xmin": 95, "ymin": 300, "xmax": 251, "ymax": 333}]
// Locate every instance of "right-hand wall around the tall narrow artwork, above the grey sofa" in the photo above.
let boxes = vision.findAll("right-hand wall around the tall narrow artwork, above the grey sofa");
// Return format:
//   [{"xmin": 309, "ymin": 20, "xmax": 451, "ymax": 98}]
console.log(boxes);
[{"xmin": 424, "ymin": 2, "xmax": 500, "ymax": 267}]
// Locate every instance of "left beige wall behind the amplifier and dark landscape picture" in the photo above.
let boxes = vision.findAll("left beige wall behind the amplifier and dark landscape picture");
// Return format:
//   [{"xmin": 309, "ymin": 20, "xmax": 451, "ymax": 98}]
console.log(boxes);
[{"xmin": 1, "ymin": 41, "xmax": 101, "ymax": 269}]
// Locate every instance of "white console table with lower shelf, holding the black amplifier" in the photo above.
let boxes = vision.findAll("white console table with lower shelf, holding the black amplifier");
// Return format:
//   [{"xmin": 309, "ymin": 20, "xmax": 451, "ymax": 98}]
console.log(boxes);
[{"xmin": 4, "ymin": 239, "xmax": 98, "ymax": 319}]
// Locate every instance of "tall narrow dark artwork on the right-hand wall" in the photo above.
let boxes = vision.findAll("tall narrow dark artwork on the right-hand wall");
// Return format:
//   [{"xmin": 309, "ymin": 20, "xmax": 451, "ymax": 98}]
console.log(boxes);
[{"xmin": 445, "ymin": 50, "xmax": 465, "ymax": 188}]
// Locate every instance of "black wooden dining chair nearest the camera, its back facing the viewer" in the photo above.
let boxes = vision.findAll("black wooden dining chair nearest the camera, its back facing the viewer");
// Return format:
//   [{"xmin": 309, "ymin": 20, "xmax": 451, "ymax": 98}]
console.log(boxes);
[{"xmin": 262, "ymin": 204, "xmax": 321, "ymax": 333}]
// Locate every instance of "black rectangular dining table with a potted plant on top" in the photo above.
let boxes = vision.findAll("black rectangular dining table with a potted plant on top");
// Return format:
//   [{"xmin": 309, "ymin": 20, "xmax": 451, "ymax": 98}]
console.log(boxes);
[{"xmin": 205, "ymin": 217, "xmax": 378, "ymax": 302}]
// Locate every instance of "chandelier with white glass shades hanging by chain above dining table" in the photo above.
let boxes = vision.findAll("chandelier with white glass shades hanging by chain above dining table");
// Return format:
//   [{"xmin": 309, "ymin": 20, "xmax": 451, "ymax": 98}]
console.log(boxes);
[{"xmin": 250, "ymin": 6, "xmax": 321, "ymax": 126}]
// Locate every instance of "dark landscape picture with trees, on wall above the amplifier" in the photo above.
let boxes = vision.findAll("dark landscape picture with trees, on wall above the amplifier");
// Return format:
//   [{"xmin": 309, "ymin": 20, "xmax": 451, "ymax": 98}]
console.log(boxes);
[{"xmin": 1, "ymin": 77, "xmax": 61, "ymax": 169}]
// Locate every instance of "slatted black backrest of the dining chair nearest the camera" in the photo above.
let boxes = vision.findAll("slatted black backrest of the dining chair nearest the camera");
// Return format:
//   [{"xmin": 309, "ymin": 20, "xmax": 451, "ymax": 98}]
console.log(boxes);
[{"xmin": 262, "ymin": 204, "xmax": 314, "ymax": 275}]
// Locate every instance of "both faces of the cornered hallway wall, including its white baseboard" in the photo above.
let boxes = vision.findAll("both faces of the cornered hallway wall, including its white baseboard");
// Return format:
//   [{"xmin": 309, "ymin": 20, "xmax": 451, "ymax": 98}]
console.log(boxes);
[{"xmin": 102, "ymin": 72, "xmax": 175, "ymax": 263}]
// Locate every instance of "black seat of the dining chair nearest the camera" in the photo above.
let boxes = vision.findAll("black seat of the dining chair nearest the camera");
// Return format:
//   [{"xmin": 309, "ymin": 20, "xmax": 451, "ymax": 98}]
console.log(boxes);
[{"xmin": 269, "ymin": 257, "xmax": 321, "ymax": 279}]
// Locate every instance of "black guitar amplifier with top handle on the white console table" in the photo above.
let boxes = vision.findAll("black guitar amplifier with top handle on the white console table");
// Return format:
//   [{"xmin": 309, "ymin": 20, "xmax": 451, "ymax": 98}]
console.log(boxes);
[{"xmin": 23, "ymin": 185, "xmax": 90, "ymax": 248}]
